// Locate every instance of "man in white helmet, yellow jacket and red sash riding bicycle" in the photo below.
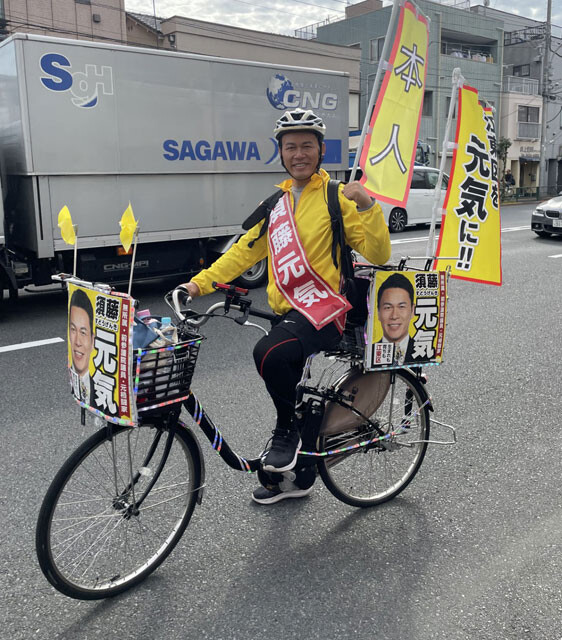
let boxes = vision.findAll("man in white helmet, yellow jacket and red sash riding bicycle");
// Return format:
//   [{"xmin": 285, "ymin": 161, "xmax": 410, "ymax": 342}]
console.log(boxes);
[{"xmin": 183, "ymin": 109, "xmax": 390, "ymax": 504}]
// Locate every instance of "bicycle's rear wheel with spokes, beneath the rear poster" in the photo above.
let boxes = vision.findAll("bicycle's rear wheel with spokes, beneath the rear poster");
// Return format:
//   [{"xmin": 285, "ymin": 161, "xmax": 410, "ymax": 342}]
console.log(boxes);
[{"xmin": 318, "ymin": 370, "xmax": 429, "ymax": 507}]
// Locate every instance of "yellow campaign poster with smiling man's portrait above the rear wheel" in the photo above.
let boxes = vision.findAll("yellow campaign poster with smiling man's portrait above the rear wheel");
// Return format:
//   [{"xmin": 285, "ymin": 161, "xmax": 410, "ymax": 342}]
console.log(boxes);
[{"xmin": 365, "ymin": 271, "xmax": 447, "ymax": 370}]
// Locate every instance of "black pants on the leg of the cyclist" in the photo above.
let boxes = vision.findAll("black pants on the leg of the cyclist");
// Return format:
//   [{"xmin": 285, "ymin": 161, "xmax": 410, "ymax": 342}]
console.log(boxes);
[{"xmin": 254, "ymin": 311, "xmax": 341, "ymax": 428}]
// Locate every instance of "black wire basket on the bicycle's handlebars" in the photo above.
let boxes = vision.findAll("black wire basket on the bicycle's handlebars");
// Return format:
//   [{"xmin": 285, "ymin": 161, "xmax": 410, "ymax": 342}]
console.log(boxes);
[{"xmin": 134, "ymin": 335, "xmax": 202, "ymax": 413}]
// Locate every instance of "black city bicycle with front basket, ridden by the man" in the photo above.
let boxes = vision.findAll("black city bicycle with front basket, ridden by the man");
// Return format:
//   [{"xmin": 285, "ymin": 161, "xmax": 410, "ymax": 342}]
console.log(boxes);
[{"xmin": 36, "ymin": 264, "xmax": 456, "ymax": 600}]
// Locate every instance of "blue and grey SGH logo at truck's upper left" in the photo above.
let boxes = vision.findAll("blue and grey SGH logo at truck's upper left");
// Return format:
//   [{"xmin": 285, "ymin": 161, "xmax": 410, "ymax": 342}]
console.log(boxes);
[{"xmin": 40, "ymin": 53, "xmax": 113, "ymax": 107}]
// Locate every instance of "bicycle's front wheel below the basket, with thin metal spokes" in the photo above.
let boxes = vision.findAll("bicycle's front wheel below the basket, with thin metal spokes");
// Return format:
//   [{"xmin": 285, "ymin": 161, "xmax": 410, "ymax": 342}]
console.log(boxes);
[{"xmin": 36, "ymin": 425, "xmax": 201, "ymax": 600}]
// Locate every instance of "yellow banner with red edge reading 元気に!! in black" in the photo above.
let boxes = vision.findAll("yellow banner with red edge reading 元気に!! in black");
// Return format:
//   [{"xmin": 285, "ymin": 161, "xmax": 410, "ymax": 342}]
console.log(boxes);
[{"xmin": 435, "ymin": 86, "xmax": 502, "ymax": 285}]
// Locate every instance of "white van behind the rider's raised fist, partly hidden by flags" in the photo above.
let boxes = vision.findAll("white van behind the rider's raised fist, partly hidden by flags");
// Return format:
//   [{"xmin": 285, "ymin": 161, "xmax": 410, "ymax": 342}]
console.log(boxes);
[{"xmin": 379, "ymin": 166, "xmax": 449, "ymax": 232}]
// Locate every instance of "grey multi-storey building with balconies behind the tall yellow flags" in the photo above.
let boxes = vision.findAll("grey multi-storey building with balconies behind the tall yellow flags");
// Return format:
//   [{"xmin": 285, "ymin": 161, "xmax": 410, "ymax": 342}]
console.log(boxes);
[{"xmin": 312, "ymin": 0, "xmax": 503, "ymax": 172}]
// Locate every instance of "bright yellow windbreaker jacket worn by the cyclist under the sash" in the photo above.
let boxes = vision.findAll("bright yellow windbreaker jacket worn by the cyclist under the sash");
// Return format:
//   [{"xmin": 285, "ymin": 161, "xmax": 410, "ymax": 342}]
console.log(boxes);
[{"xmin": 192, "ymin": 169, "xmax": 390, "ymax": 314}]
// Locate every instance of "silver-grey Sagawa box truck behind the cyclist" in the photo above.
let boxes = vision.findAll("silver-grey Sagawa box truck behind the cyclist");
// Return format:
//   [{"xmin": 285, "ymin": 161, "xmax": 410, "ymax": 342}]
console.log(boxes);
[{"xmin": 0, "ymin": 34, "xmax": 349, "ymax": 302}]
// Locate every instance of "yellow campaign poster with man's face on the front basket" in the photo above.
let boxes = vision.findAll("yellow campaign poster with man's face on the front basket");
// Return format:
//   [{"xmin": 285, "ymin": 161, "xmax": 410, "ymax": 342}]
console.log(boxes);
[{"xmin": 68, "ymin": 283, "xmax": 137, "ymax": 425}]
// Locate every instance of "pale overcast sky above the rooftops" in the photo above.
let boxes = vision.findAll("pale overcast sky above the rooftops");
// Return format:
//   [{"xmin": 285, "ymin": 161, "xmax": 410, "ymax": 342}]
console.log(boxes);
[{"xmin": 125, "ymin": 0, "xmax": 562, "ymax": 35}]
